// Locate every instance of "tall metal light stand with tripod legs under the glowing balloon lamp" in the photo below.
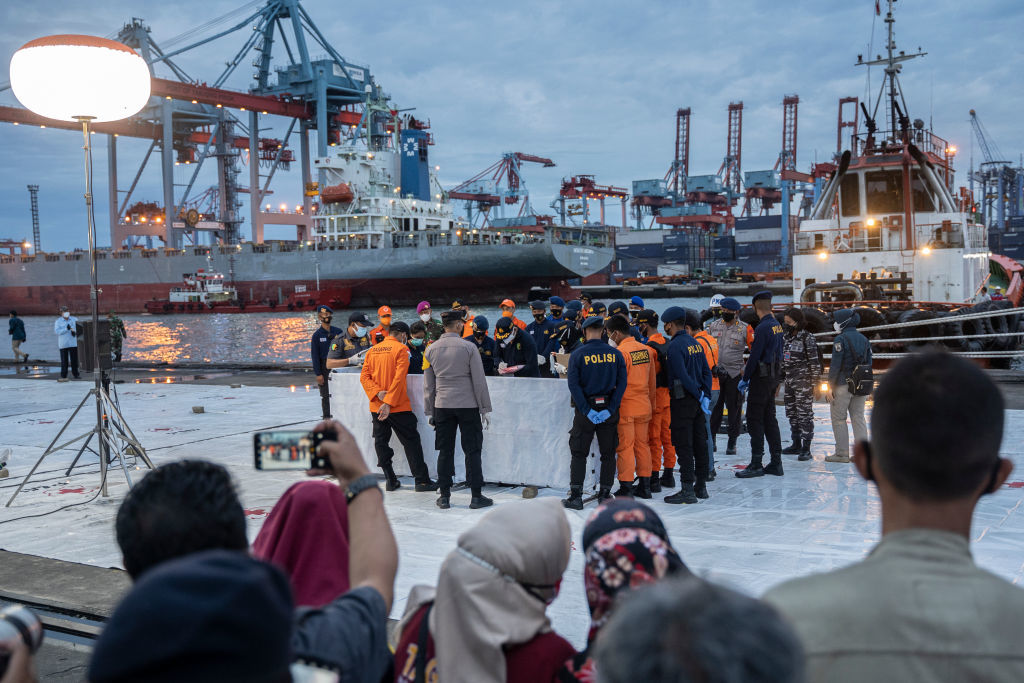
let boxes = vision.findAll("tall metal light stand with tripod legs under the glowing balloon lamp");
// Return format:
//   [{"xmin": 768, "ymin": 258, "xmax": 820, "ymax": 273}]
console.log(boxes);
[{"xmin": 6, "ymin": 117, "xmax": 153, "ymax": 508}]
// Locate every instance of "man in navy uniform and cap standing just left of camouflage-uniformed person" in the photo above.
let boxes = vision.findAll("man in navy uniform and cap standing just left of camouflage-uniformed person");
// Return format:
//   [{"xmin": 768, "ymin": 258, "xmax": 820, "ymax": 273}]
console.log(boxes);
[{"xmin": 736, "ymin": 290, "xmax": 783, "ymax": 479}]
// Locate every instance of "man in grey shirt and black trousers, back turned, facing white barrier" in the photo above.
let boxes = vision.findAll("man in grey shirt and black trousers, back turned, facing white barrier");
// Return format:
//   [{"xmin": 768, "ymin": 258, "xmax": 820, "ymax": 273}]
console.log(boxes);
[{"xmin": 423, "ymin": 311, "xmax": 494, "ymax": 510}]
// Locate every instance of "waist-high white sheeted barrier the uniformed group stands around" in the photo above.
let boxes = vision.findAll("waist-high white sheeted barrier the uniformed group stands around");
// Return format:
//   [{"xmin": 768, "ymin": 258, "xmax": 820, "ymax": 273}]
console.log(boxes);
[{"xmin": 331, "ymin": 371, "xmax": 599, "ymax": 488}]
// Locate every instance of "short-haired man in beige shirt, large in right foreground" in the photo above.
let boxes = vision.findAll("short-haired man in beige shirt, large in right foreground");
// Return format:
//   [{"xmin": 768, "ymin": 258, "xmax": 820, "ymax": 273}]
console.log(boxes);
[{"xmin": 765, "ymin": 352, "xmax": 1024, "ymax": 683}]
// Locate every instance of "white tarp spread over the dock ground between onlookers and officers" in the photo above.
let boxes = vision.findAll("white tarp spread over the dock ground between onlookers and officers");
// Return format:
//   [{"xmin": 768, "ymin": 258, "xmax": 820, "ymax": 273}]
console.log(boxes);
[{"xmin": 0, "ymin": 378, "xmax": 1024, "ymax": 647}]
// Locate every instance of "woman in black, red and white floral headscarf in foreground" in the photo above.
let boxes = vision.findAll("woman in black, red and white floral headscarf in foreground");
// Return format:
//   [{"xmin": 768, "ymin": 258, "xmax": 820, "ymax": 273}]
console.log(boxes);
[{"xmin": 558, "ymin": 498, "xmax": 690, "ymax": 683}]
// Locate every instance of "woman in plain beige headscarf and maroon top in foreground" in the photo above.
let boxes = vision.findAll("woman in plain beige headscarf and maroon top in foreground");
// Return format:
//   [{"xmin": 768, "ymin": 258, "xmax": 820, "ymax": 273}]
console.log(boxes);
[{"xmin": 394, "ymin": 498, "xmax": 573, "ymax": 683}]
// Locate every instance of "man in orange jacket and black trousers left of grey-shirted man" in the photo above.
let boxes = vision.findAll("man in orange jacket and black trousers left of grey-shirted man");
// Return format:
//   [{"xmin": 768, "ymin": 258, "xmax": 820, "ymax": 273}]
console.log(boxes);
[{"xmin": 359, "ymin": 321, "xmax": 437, "ymax": 492}]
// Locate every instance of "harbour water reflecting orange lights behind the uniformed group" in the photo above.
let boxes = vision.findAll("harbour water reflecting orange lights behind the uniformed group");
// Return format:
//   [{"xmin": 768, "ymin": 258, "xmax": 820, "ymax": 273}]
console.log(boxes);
[{"xmin": 9, "ymin": 296, "xmax": 792, "ymax": 364}]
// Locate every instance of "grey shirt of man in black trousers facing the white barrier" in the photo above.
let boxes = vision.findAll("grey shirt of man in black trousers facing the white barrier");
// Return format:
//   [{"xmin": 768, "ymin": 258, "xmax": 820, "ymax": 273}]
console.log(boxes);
[{"xmin": 423, "ymin": 332, "xmax": 490, "ymax": 416}]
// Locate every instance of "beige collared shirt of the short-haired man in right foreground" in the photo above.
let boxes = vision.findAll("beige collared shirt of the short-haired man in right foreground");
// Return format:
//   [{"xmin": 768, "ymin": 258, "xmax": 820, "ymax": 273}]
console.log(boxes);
[{"xmin": 764, "ymin": 528, "xmax": 1024, "ymax": 683}]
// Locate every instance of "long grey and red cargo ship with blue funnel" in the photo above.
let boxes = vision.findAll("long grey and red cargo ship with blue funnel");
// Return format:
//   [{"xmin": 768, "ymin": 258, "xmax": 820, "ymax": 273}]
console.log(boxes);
[{"xmin": 0, "ymin": 117, "xmax": 614, "ymax": 315}]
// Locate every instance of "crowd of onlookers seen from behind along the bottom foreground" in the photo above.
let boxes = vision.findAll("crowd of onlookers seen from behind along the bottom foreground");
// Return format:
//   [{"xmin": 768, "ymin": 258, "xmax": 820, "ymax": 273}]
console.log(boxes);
[{"xmin": 2, "ymin": 352, "xmax": 1024, "ymax": 683}]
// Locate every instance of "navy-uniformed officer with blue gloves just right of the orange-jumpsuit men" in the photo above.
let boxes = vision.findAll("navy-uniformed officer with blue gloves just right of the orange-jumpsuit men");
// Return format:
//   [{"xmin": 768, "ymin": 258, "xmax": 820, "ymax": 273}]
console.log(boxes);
[{"xmin": 662, "ymin": 306, "xmax": 711, "ymax": 504}]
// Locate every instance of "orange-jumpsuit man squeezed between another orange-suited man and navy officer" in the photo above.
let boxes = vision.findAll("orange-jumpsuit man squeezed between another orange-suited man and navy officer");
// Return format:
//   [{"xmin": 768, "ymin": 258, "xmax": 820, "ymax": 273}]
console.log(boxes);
[{"xmin": 637, "ymin": 308, "xmax": 676, "ymax": 494}]
